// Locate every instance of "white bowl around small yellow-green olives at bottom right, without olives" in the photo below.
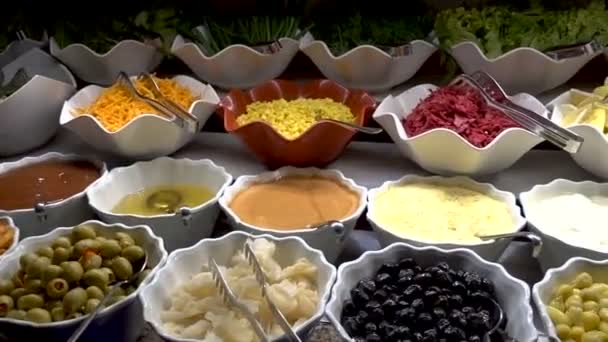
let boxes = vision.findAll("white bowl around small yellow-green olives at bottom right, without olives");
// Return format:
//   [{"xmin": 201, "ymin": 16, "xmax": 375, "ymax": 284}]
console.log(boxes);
[{"xmin": 532, "ymin": 257, "xmax": 608, "ymax": 341}]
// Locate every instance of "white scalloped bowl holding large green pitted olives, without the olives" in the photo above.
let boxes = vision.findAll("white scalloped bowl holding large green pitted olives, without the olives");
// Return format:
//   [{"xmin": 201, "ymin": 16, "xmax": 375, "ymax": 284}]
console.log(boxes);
[{"xmin": 0, "ymin": 221, "xmax": 167, "ymax": 341}]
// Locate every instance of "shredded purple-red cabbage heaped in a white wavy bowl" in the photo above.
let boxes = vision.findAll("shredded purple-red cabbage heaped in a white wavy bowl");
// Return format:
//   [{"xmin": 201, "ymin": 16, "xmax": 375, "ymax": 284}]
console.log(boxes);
[{"xmin": 403, "ymin": 85, "xmax": 521, "ymax": 148}]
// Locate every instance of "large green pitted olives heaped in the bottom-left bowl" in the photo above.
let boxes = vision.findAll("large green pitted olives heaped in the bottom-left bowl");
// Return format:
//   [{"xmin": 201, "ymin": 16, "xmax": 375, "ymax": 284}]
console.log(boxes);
[{"xmin": 0, "ymin": 224, "xmax": 149, "ymax": 323}]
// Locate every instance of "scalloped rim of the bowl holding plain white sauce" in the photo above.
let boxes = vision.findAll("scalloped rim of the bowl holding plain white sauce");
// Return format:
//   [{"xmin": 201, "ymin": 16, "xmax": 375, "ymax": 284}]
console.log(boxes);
[{"xmin": 519, "ymin": 178, "xmax": 608, "ymax": 254}]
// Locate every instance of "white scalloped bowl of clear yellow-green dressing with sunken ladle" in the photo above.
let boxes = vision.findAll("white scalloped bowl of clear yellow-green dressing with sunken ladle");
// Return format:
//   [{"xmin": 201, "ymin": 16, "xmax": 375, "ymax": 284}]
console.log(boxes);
[{"xmin": 87, "ymin": 157, "xmax": 232, "ymax": 251}]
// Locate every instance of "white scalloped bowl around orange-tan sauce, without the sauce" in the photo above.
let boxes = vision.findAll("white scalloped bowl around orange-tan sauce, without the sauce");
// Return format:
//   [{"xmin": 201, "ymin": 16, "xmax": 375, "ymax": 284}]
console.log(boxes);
[{"xmin": 220, "ymin": 166, "xmax": 367, "ymax": 262}]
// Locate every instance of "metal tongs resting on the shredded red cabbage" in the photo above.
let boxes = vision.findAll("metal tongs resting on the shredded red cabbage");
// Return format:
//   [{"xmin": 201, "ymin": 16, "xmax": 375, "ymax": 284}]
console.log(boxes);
[{"xmin": 450, "ymin": 71, "xmax": 584, "ymax": 153}]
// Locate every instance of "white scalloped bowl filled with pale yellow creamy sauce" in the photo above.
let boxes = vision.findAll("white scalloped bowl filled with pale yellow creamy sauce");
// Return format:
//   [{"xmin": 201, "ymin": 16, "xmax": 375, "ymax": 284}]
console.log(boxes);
[{"xmin": 367, "ymin": 175, "xmax": 526, "ymax": 261}]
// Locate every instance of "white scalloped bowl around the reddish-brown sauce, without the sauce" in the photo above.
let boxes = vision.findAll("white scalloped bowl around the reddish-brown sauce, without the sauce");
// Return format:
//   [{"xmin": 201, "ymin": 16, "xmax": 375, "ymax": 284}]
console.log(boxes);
[{"xmin": 0, "ymin": 152, "xmax": 107, "ymax": 238}]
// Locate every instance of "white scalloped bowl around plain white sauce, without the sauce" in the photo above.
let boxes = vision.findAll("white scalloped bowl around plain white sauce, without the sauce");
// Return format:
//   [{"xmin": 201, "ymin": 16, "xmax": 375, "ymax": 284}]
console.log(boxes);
[{"xmin": 519, "ymin": 179, "xmax": 608, "ymax": 271}]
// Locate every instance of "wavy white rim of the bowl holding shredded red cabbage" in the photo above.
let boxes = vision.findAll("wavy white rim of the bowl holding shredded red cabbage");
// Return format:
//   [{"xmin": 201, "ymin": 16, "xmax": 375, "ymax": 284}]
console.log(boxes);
[{"xmin": 372, "ymin": 83, "xmax": 547, "ymax": 152}]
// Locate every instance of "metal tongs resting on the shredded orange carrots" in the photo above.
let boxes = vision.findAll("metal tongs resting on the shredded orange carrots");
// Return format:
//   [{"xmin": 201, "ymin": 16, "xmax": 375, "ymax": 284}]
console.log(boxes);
[{"xmin": 117, "ymin": 71, "xmax": 200, "ymax": 133}]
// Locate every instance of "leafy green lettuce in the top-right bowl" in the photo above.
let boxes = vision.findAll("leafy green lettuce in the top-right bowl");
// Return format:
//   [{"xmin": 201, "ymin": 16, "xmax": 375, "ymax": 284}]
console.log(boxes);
[{"xmin": 435, "ymin": 0, "xmax": 608, "ymax": 58}]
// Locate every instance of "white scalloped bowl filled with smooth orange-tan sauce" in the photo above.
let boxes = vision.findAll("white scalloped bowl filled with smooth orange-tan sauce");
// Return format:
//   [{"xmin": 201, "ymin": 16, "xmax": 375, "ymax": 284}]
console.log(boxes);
[{"xmin": 219, "ymin": 166, "xmax": 367, "ymax": 262}]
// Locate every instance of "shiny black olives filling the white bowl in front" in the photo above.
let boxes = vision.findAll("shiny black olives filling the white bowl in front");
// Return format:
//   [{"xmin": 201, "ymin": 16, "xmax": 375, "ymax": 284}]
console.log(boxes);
[{"xmin": 341, "ymin": 258, "xmax": 505, "ymax": 342}]
